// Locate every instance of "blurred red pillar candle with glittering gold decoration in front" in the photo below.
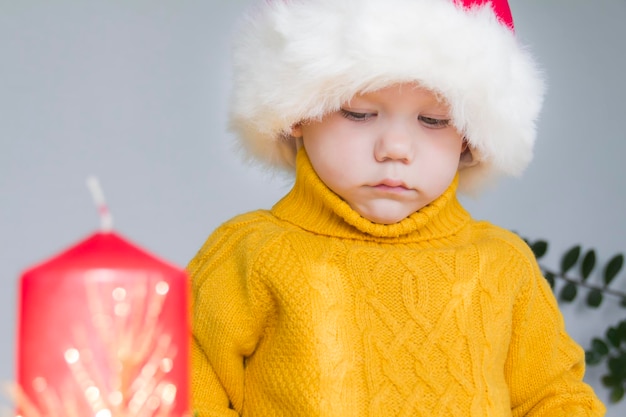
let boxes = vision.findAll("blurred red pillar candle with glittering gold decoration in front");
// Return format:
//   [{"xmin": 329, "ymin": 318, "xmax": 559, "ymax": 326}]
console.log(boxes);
[{"xmin": 16, "ymin": 180, "xmax": 190, "ymax": 417}]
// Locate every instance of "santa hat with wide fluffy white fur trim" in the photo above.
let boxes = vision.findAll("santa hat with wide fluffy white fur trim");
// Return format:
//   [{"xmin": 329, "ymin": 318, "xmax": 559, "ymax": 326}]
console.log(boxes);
[{"xmin": 230, "ymin": 0, "xmax": 544, "ymax": 191}]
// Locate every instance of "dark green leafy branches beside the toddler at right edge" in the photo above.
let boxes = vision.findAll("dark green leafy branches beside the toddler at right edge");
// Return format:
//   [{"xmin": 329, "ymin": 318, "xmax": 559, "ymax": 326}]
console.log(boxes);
[{"xmin": 527, "ymin": 240, "xmax": 626, "ymax": 403}]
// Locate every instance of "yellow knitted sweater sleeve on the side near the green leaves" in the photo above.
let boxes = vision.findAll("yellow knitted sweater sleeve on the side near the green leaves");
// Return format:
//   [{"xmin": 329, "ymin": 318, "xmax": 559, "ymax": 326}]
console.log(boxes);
[{"xmin": 505, "ymin": 242, "xmax": 605, "ymax": 417}]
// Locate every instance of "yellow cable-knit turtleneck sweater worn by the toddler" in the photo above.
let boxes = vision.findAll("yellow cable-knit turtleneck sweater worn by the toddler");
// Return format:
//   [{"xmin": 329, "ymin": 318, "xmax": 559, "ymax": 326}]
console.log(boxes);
[{"xmin": 189, "ymin": 151, "xmax": 604, "ymax": 417}]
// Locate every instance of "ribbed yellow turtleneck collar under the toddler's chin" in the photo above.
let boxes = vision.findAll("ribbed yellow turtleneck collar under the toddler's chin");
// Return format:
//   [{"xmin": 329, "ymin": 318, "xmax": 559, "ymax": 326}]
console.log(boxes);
[{"xmin": 272, "ymin": 148, "xmax": 470, "ymax": 243}]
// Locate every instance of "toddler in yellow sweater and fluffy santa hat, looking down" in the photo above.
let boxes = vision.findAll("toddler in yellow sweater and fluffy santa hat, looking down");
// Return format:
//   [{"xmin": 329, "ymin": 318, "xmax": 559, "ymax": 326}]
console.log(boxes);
[{"xmin": 188, "ymin": 0, "xmax": 604, "ymax": 417}]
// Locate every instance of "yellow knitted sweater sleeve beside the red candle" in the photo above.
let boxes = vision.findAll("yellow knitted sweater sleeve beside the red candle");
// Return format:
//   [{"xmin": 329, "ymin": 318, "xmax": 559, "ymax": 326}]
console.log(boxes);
[{"xmin": 188, "ymin": 218, "xmax": 270, "ymax": 417}]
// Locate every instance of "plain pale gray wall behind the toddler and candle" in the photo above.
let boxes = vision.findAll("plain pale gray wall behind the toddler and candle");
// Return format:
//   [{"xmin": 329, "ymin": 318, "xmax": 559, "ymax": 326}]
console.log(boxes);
[{"xmin": 0, "ymin": 0, "xmax": 626, "ymax": 416}]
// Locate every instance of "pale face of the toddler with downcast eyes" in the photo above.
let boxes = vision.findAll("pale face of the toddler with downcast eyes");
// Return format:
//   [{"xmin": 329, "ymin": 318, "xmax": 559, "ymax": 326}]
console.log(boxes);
[{"xmin": 292, "ymin": 84, "xmax": 463, "ymax": 224}]
